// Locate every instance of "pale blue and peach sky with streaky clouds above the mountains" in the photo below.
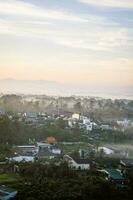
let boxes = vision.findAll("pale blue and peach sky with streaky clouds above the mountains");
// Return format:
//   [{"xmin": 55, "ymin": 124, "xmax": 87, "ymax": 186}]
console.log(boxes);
[{"xmin": 0, "ymin": 0, "xmax": 133, "ymax": 87}]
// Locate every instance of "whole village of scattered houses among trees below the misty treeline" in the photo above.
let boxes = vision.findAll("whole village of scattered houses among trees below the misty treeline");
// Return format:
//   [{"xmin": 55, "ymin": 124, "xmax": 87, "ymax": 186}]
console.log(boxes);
[{"xmin": 0, "ymin": 109, "xmax": 133, "ymax": 200}]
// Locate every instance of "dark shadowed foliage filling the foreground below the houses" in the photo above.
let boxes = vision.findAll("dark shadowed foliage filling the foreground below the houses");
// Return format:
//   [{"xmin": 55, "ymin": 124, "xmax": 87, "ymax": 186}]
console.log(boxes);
[{"xmin": 9, "ymin": 163, "xmax": 133, "ymax": 200}]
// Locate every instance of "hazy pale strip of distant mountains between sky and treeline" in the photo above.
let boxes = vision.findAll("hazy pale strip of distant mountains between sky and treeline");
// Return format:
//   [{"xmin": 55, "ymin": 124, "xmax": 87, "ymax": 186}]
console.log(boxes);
[{"xmin": 0, "ymin": 79, "xmax": 133, "ymax": 99}]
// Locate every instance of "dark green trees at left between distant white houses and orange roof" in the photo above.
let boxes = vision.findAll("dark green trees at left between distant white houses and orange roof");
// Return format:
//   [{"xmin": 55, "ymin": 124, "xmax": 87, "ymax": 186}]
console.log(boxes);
[{"xmin": 0, "ymin": 116, "xmax": 85, "ymax": 144}]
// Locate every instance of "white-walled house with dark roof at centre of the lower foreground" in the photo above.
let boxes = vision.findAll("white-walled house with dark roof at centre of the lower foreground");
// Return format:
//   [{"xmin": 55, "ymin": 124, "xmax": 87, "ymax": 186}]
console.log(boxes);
[{"xmin": 64, "ymin": 155, "xmax": 91, "ymax": 170}]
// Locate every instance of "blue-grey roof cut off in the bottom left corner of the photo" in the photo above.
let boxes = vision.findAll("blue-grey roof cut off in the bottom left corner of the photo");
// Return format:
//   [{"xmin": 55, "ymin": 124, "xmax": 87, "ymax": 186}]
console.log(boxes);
[{"xmin": 0, "ymin": 185, "xmax": 17, "ymax": 200}]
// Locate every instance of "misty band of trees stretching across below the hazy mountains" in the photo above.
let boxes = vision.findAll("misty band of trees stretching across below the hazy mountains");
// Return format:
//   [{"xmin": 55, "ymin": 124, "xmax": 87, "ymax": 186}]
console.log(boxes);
[{"xmin": 0, "ymin": 95, "xmax": 133, "ymax": 120}]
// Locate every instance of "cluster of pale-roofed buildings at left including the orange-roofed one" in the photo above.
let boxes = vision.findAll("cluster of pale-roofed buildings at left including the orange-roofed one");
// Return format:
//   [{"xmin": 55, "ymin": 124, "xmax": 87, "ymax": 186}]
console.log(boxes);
[{"xmin": 9, "ymin": 137, "xmax": 61, "ymax": 162}]
